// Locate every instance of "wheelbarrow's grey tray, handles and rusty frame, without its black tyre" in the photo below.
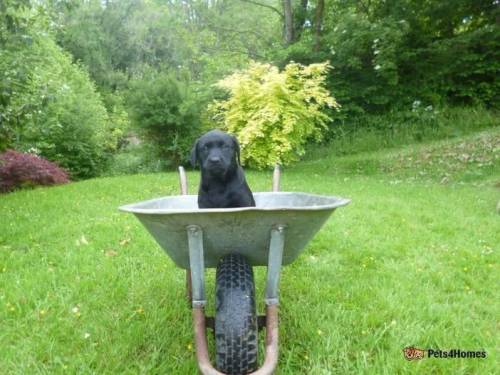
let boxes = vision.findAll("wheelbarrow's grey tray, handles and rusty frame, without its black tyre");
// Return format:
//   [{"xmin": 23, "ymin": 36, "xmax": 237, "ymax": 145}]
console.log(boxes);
[{"xmin": 120, "ymin": 167, "xmax": 350, "ymax": 375}]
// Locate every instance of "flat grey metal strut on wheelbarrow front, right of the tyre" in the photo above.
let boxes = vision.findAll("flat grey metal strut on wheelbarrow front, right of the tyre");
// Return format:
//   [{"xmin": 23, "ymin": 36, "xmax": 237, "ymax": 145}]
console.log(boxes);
[{"xmin": 265, "ymin": 225, "xmax": 285, "ymax": 306}]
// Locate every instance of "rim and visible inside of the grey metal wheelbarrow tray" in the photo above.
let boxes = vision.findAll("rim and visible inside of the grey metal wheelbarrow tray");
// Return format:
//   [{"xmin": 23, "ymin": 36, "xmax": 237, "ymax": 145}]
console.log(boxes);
[{"xmin": 119, "ymin": 192, "xmax": 351, "ymax": 215}]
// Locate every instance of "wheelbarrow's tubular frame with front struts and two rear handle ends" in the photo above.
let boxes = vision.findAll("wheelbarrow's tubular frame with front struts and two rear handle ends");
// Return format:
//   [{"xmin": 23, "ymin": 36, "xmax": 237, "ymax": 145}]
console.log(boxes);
[{"xmin": 179, "ymin": 166, "xmax": 286, "ymax": 375}]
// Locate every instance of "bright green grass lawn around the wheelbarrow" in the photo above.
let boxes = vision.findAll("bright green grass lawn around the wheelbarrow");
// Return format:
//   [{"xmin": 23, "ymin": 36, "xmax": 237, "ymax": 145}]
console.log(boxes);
[{"xmin": 0, "ymin": 128, "xmax": 500, "ymax": 374}]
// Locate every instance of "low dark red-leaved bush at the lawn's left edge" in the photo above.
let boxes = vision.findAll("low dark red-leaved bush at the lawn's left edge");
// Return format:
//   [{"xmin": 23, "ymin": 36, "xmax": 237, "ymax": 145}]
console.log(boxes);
[{"xmin": 0, "ymin": 150, "xmax": 69, "ymax": 192}]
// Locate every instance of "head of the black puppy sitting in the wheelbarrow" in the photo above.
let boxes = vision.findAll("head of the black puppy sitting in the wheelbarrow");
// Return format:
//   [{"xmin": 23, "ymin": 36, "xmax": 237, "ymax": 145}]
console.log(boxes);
[{"xmin": 191, "ymin": 130, "xmax": 240, "ymax": 177}]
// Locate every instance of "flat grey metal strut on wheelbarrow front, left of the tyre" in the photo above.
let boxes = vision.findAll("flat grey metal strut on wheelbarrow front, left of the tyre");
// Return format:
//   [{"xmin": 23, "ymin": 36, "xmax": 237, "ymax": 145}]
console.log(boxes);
[{"xmin": 187, "ymin": 225, "xmax": 206, "ymax": 307}]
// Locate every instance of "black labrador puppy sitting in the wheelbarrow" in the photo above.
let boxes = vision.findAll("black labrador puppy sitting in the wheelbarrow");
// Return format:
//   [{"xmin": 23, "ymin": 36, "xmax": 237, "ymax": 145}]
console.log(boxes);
[{"xmin": 191, "ymin": 130, "xmax": 255, "ymax": 208}]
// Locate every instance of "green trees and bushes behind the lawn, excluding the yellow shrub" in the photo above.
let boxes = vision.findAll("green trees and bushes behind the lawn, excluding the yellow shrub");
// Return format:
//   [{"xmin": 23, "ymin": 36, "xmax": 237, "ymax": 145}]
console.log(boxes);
[{"xmin": 0, "ymin": 0, "xmax": 500, "ymax": 178}]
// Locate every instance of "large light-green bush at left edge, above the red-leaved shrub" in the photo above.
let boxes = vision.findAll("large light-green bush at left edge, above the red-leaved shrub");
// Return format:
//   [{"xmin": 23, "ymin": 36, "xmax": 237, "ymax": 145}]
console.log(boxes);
[{"xmin": 0, "ymin": 5, "xmax": 117, "ymax": 178}]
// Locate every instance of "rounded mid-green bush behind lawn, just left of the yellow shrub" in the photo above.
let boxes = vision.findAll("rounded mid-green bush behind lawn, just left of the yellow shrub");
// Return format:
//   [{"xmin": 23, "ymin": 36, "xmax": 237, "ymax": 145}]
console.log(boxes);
[{"xmin": 127, "ymin": 70, "xmax": 200, "ymax": 165}]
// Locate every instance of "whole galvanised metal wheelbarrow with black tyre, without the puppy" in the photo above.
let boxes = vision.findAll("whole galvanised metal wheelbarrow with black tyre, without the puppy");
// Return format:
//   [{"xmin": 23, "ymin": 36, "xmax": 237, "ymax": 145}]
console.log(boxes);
[{"xmin": 120, "ymin": 167, "xmax": 350, "ymax": 375}]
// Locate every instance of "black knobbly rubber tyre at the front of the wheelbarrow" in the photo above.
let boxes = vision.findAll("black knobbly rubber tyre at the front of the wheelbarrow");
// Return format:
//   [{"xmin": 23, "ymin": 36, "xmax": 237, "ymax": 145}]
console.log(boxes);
[{"xmin": 215, "ymin": 254, "xmax": 258, "ymax": 375}]
